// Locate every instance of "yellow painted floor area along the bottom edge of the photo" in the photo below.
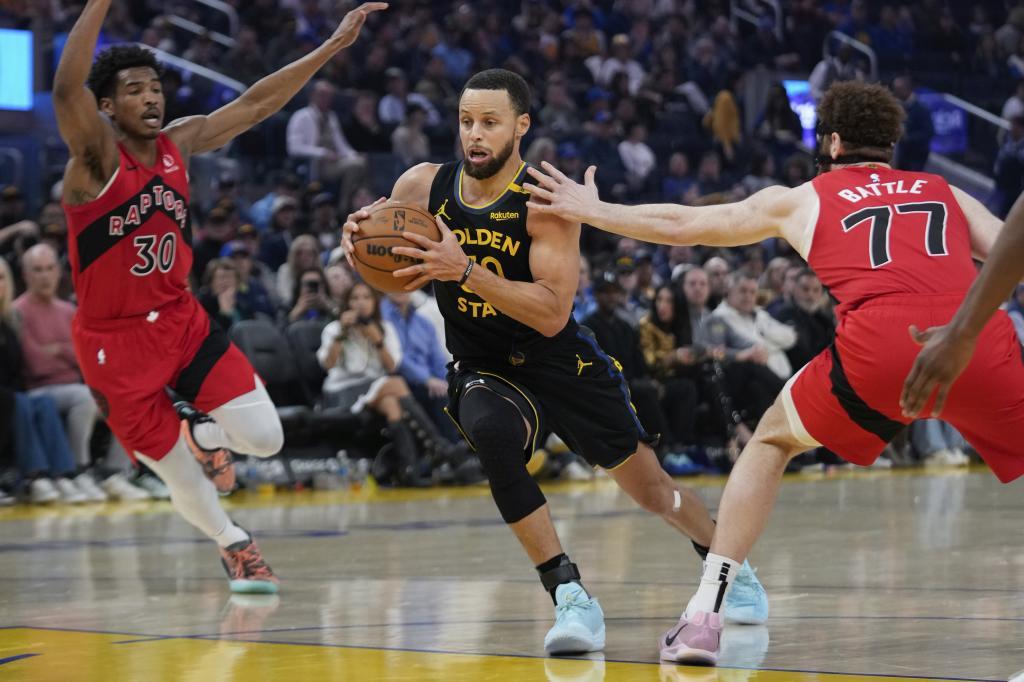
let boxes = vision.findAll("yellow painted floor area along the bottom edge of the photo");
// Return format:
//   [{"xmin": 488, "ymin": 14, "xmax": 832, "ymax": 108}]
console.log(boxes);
[{"xmin": 0, "ymin": 628, "xmax": 974, "ymax": 682}]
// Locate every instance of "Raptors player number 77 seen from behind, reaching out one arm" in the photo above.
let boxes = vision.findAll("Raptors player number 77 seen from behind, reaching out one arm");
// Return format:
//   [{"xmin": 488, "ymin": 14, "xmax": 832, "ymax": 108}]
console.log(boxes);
[{"xmin": 523, "ymin": 82, "xmax": 1024, "ymax": 663}]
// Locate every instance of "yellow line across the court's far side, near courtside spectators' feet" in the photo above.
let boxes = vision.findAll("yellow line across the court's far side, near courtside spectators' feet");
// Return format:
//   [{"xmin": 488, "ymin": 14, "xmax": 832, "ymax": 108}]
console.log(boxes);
[{"xmin": 0, "ymin": 465, "xmax": 991, "ymax": 523}]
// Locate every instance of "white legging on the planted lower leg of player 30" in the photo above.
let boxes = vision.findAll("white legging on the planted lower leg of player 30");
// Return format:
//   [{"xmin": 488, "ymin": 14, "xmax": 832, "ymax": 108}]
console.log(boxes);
[{"xmin": 135, "ymin": 437, "xmax": 249, "ymax": 547}]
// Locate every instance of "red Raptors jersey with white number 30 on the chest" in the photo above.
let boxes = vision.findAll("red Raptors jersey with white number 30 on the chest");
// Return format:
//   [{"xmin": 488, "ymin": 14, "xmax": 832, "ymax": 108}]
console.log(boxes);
[{"xmin": 63, "ymin": 133, "xmax": 193, "ymax": 319}]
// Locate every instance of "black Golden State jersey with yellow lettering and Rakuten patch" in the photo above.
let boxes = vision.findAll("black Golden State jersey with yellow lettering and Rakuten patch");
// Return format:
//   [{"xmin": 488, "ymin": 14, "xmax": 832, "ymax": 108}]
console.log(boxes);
[{"xmin": 429, "ymin": 162, "xmax": 577, "ymax": 366}]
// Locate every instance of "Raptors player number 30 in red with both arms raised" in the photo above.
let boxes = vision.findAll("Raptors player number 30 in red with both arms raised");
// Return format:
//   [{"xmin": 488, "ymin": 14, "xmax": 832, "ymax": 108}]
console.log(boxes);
[{"xmin": 53, "ymin": 0, "xmax": 387, "ymax": 592}]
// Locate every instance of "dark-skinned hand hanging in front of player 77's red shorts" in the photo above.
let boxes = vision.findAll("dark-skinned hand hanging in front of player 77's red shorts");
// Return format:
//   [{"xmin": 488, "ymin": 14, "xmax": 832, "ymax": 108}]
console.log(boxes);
[{"xmin": 899, "ymin": 325, "xmax": 976, "ymax": 419}]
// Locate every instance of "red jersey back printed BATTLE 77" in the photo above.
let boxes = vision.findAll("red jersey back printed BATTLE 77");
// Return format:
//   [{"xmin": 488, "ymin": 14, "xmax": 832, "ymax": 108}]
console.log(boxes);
[{"xmin": 806, "ymin": 166, "xmax": 976, "ymax": 317}]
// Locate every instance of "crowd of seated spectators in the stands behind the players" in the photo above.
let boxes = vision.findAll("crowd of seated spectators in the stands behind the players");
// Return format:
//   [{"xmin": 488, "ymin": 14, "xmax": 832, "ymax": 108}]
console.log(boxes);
[{"xmin": 0, "ymin": 0, "xmax": 1024, "ymax": 501}]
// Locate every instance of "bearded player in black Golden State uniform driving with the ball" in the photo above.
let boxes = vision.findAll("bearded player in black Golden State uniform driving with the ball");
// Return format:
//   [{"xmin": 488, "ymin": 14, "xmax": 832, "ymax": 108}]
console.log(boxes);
[{"xmin": 343, "ymin": 69, "xmax": 766, "ymax": 653}]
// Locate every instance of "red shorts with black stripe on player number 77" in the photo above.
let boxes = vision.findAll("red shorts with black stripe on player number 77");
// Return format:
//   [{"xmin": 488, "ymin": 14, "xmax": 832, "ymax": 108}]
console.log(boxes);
[{"xmin": 780, "ymin": 295, "xmax": 1024, "ymax": 482}]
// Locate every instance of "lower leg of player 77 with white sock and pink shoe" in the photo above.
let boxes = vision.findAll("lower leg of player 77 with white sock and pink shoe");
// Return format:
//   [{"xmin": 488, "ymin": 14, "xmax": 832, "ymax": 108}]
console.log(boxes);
[{"xmin": 658, "ymin": 399, "xmax": 807, "ymax": 664}]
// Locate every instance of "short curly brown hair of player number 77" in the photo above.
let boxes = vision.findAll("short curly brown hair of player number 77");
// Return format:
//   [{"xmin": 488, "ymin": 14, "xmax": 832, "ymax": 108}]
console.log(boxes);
[{"xmin": 818, "ymin": 81, "xmax": 906, "ymax": 159}]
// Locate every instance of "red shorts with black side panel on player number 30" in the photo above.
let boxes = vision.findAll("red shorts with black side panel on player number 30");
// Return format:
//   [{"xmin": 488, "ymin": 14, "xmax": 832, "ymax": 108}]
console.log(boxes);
[{"xmin": 73, "ymin": 296, "xmax": 259, "ymax": 460}]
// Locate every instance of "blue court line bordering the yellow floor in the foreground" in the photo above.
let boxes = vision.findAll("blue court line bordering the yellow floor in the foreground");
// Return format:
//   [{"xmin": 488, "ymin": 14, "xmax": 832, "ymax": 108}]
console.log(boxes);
[{"xmin": 0, "ymin": 626, "xmax": 1001, "ymax": 682}]
